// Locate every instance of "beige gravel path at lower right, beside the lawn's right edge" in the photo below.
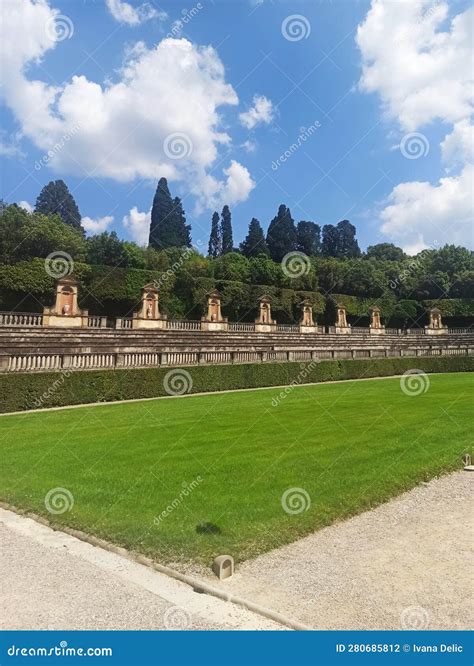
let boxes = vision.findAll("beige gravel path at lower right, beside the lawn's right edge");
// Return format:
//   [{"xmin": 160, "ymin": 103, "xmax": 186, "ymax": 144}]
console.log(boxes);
[{"xmin": 191, "ymin": 471, "xmax": 474, "ymax": 630}]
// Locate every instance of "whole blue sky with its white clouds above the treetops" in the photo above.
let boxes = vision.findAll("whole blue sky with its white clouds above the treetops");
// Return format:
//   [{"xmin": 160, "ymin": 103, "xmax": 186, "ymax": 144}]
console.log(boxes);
[{"xmin": 0, "ymin": 0, "xmax": 472, "ymax": 252}]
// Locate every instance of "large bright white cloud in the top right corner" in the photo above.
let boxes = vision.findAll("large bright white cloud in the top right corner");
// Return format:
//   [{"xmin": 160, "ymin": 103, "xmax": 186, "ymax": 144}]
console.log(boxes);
[{"xmin": 356, "ymin": 0, "xmax": 473, "ymax": 132}]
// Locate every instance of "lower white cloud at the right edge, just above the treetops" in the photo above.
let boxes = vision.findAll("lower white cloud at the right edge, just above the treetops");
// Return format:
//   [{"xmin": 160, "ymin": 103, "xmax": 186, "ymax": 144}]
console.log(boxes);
[{"xmin": 380, "ymin": 165, "xmax": 474, "ymax": 253}]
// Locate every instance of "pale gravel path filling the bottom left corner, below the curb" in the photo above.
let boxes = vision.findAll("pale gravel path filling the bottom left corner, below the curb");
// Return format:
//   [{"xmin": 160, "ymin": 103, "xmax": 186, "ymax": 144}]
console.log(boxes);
[{"xmin": 0, "ymin": 509, "xmax": 285, "ymax": 630}]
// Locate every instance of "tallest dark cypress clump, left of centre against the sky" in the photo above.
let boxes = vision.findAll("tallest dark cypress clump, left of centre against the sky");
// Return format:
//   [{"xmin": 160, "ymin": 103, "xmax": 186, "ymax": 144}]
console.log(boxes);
[{"xmin": 149, "ymin": 178, "xmax": 191, "ymax": 250}]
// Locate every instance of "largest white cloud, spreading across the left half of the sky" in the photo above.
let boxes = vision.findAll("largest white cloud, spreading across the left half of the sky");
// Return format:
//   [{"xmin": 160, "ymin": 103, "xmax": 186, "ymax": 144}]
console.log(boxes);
[{"xmin": 0, "ymin": 0, "xmax": 251, "ymax": 206}]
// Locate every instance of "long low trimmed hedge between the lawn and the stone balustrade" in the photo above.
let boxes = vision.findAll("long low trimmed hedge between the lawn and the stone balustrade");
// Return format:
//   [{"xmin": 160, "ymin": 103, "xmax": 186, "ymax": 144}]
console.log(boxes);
[{"xmin": 0, "ymin": 356, "xmax": 474, "ymax": 413}]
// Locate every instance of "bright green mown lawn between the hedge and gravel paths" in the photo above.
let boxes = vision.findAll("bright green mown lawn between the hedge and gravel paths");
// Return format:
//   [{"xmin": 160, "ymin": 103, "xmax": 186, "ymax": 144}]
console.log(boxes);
[{"xmin": 0, "ymin": 373, "xmax": 474, "ymax": 564}]
